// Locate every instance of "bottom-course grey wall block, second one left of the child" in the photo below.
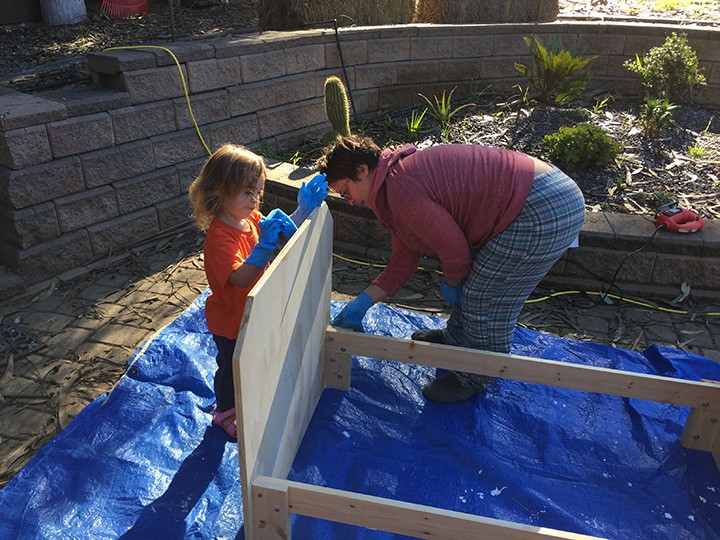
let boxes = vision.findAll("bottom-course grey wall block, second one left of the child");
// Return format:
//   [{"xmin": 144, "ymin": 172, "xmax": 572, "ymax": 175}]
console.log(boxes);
[{"xmin": 87, "ymin": 207, "xmax": 160, "ymax": 257}]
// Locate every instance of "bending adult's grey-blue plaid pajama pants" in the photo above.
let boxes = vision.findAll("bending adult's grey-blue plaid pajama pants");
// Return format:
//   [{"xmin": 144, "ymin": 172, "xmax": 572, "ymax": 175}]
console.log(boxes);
[{"xmin": 443, "ymin": 169, "xmax": 585, "ymax": 384}]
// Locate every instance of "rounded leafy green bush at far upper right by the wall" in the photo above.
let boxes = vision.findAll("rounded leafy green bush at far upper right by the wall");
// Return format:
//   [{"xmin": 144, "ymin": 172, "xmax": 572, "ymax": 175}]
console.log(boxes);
[{"xmin": 623, "ymin": 32, "xmax": 707, "ymax": 103}]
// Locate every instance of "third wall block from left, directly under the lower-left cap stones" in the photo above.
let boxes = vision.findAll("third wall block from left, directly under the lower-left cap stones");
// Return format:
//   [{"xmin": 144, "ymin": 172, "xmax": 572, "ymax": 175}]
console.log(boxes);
[{"xmin": 109, "ymin": 98, "xmax": 178, "ymax": 144}]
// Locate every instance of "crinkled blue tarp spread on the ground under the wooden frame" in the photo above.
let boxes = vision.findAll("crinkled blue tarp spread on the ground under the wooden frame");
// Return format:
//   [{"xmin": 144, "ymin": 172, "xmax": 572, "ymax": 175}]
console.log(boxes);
[{"xmin": 0, "ymin": 293, "xmax": 720, "ymax": 540}]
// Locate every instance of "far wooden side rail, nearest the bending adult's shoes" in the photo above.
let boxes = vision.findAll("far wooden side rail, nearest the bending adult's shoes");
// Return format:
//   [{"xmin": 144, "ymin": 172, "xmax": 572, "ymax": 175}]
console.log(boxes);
[{"xmin": 325, "ymin": 326, "xmax": 720, "ymax": 409}]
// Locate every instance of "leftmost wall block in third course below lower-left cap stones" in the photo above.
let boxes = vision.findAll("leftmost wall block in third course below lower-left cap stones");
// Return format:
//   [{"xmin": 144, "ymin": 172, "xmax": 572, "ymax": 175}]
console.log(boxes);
[{"xmin": 0, "ymin": 202, "xmax": 60, "ymax": 249}]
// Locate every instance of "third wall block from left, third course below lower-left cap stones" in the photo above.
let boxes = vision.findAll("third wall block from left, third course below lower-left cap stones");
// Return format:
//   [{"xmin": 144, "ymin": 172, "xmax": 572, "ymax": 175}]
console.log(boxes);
[{"xmin": 112, "ymin": 167, "xmax": 180, "ymax": 214}]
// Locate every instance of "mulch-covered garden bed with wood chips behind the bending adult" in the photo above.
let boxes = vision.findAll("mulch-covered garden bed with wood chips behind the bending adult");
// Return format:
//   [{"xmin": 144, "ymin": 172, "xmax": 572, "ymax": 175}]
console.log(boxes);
[{"xmin": 292, "ymin": 94, "xmax": 720, "ymax": 219}]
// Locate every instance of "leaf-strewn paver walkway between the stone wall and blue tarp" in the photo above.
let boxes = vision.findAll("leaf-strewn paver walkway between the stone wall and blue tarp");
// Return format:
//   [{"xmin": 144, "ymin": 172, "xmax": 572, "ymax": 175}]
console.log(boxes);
[{"xmin": 0, "ymin": 226, "xmax": 720, "ymax": 487}]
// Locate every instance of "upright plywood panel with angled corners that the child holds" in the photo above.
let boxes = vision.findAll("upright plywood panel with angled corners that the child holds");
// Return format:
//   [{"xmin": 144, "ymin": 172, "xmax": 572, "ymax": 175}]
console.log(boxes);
[{"xmin": 233, "ymin": 204, "xmax": 332, "ymax": 540}]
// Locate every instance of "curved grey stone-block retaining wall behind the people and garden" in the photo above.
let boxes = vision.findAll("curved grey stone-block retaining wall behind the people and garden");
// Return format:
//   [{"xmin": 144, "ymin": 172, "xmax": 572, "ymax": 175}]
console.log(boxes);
[{"xmin": 0, "ymin": 22, "xmax": 720, "ymax": 296}]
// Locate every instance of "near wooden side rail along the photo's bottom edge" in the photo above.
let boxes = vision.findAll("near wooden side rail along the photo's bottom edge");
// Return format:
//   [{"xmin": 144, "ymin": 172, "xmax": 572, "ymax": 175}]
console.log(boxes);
[{"xmin": 256, "ymin": 477, "xmax": 597, "ymax": 540}]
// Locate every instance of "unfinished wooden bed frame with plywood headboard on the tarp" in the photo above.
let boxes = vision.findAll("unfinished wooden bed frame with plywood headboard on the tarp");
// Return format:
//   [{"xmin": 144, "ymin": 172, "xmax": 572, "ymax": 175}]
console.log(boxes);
[{"xmin": 233, "ymin": 204, "xmax": 720, "ymax": 540}]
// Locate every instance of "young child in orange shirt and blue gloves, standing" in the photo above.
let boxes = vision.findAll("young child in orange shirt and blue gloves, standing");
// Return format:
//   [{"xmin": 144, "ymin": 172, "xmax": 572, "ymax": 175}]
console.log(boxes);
[{"xmin": 189, "ymin": 144, "xmax": 327, "ymax": 439}]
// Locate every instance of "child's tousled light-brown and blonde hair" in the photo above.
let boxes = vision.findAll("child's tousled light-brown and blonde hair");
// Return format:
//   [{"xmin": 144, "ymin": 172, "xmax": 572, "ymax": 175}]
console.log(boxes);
[{"xmin": 188, "ymin": 144, "xmax": 266, "ymax": 231}]
